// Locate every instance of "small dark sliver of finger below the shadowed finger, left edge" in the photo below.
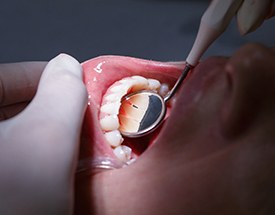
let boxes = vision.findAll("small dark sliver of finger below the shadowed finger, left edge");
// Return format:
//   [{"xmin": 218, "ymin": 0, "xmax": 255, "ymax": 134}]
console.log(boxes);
[{"xmin": 0, "ymin": 102, "xmax": 29, "ymax": 121}]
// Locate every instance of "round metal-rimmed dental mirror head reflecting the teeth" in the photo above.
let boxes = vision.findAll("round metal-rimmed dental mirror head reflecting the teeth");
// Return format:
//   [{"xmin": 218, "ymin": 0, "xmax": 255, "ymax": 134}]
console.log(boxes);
[{"xmin": 118, "ymin": 91, "xmax": 166, "ymax": 137}]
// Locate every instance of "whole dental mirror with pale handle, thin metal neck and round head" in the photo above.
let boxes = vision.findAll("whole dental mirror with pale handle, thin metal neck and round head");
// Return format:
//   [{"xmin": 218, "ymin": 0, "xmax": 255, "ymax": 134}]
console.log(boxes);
[{"xmin": 119, "ymin": 0, "xmax": 242, "ymax": 138}]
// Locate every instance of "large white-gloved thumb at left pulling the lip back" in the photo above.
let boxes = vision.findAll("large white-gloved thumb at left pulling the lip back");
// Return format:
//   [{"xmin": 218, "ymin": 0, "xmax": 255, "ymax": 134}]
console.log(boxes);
[{"xmin": 0, "ymin": 54, "xmax": 87, "ymax": 214}]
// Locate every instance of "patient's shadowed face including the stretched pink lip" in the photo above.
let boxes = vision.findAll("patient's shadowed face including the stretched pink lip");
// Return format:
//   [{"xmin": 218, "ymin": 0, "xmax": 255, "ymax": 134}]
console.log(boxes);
[{"xmin": 76, "ymin": 44, "xmax": 275, "ymax": 214}]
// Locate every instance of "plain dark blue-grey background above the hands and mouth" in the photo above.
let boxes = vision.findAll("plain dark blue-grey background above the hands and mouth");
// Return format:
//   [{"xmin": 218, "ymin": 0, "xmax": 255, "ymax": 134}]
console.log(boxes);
[{"xmin": 0, "ymin": 0, "xmax": 275, "ymax": 63}]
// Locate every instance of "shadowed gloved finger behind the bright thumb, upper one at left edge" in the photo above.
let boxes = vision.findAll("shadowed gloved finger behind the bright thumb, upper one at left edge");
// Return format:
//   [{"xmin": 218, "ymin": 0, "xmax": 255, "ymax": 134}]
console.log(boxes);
[{"xmin": 0, "ymin": 62, "xmax": 46, "ymax": 106}]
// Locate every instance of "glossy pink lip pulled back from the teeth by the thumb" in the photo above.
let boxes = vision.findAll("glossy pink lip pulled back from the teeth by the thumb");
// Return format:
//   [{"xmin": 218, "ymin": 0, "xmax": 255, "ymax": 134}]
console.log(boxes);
[{"xmin": 80, "ymin": 56, "xmax": 188, "ymax": 168}]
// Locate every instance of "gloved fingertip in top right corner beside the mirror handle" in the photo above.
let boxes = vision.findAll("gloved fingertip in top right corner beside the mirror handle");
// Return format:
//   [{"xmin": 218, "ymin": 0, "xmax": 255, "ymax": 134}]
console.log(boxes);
[{"xmin": 237, "ymin": 0, "xmax": 271, "ymax": 35}]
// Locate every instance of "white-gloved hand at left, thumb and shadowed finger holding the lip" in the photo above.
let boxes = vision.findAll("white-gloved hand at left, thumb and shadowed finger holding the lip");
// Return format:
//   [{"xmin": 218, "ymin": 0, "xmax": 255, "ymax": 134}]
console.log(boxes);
[{"xmin": 0, "ymin": 54, "xmax": 87, "ymax": 214}]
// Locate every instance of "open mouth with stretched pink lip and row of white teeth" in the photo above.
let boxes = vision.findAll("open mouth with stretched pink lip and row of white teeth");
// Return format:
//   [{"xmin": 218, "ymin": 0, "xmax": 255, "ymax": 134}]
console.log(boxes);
[{"xmin": 80, "ymin": 56, "xmax": 189, "ymax": 168}]
